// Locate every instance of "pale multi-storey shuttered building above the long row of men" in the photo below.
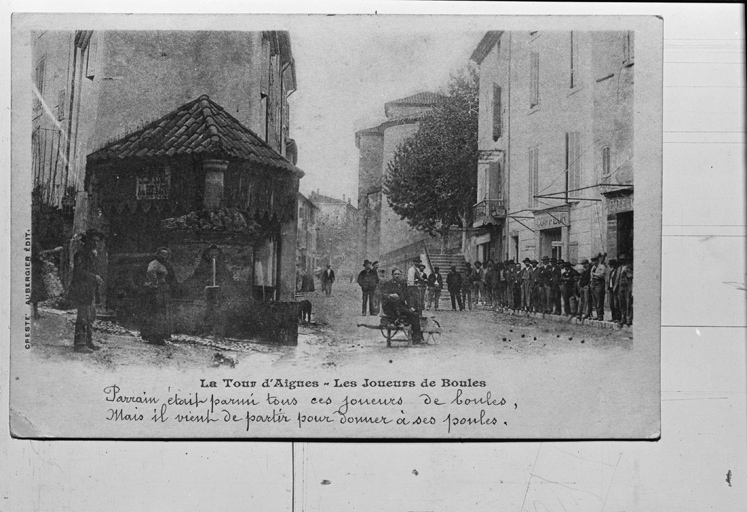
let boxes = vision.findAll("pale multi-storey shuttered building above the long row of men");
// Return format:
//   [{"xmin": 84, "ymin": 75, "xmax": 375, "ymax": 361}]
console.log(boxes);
[{"xmin": 471, "ymin": 31, "xmax": 635, "ymax": 262}]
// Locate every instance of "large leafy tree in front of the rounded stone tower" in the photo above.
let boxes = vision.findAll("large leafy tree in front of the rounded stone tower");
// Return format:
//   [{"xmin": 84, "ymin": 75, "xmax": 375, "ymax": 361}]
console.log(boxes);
[{"xmin": 383, "ymin": 67, "xmax": 479, "ymax": 254}]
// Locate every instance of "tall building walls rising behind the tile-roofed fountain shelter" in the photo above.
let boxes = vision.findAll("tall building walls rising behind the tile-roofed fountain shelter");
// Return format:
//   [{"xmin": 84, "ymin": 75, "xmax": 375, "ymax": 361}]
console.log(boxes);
[{"xmin": 30, "ymin": 31, "xmax": 297, "ymax": 298}]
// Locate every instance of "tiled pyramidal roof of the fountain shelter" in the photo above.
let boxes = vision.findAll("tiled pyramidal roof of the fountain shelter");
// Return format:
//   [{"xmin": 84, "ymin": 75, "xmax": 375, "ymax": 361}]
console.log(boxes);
[{"xmin": 88, "ymin": 95, "xmax": 301, "ymax": 176}]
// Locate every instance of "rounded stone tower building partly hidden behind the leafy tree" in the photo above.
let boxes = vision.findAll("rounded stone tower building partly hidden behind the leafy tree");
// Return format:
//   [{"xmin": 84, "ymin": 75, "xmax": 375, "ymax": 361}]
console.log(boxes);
[{"xmin": 355, "ymin": 92, "xmax": 444, "ymax": 265}]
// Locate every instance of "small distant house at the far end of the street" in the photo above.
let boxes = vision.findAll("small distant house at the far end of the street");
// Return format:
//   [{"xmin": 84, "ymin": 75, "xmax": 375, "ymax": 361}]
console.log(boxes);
[{"xmin": 309, "ymin": 191, "xmax": 360, "ymax": 275}]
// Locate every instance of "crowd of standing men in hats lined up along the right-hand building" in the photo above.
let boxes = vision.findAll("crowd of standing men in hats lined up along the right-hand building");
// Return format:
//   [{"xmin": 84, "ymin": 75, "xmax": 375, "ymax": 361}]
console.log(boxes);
[{"xmin": 357, "ymin": 254, "xmax": 633, "ymax": 325}]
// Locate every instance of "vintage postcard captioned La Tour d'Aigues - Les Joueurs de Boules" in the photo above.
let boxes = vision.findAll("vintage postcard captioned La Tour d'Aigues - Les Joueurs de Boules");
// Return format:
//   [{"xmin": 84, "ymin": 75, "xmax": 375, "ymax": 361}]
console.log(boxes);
[{"xmin": 10, "ymin": 14, "xmax": 662, "ymax": 439}]
